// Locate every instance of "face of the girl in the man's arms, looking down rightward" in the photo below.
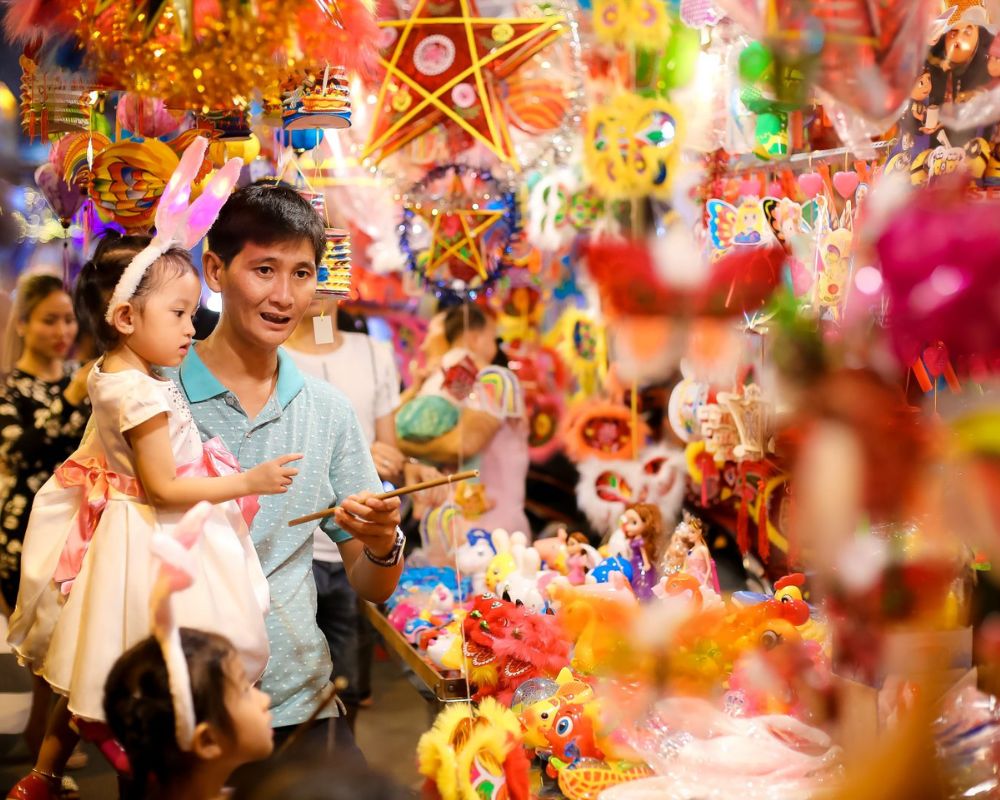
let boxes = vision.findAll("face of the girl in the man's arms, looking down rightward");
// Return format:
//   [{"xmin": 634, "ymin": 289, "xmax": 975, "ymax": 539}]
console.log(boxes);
[{"xmin": 125, "ymin": 270, "xmax": 201, "ymax": 367}]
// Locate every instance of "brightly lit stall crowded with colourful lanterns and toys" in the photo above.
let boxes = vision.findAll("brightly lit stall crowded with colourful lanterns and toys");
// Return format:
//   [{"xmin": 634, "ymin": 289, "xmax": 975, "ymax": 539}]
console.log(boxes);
[{"xmin": 4, "ymin": 0, "xmax": 1000, "ymax": 800}]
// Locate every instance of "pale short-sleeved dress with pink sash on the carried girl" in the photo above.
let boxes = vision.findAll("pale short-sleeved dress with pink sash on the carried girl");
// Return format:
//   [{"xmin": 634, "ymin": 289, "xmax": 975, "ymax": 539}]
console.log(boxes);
[{"xmin": 8, "ymin": 364, "xmax": 269, "ymax": 721}]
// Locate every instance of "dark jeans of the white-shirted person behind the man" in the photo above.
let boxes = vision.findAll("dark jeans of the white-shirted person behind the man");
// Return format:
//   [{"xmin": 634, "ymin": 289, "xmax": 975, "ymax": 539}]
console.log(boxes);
[{"xmin": 313, "ymin": 561, "xmax": 368, "ymax": 708}]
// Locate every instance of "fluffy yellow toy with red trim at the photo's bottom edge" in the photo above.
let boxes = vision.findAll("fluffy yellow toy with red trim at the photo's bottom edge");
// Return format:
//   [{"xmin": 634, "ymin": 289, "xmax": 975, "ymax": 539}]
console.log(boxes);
[{"xmin": 417, "ymin": 698, "xmax": 531, "ymax": 800}]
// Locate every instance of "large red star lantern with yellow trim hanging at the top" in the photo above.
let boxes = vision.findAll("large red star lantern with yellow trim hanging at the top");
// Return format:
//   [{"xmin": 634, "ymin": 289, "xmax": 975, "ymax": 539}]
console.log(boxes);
[{"xmin": 364, "ymin": 0, "xmax": 566, "ymax": 166}]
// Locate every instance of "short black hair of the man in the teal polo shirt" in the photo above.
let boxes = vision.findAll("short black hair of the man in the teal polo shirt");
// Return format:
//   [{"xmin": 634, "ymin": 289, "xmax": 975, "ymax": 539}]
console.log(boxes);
[{"xmin": 208, "ymin": 180, "xmax": 326, "ymax": 267}]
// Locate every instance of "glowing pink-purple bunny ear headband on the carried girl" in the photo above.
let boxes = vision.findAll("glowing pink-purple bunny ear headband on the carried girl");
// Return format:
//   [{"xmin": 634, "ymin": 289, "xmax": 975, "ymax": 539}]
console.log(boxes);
[{"xmin": 104, "ymin": 136, "xmax": 243, "ymax": 325}]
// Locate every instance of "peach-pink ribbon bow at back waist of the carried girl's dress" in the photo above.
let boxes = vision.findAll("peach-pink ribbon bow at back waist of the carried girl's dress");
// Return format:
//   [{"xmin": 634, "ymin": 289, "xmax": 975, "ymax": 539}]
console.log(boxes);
[{"xmin": 55, "ymin": 456, "xmax": 142, "ymax": 594}]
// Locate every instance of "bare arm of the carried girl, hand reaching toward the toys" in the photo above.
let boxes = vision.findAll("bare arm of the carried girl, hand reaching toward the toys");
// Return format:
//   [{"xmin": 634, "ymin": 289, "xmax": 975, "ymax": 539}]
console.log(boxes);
[{"xmin": 125, "ymin": 413, "xmax": 302, "ymax": 511}]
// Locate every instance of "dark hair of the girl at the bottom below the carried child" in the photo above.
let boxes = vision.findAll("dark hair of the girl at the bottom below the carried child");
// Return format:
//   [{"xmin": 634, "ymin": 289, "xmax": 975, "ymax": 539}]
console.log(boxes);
[{"xmin": 104, "ymin": 628, "xmax": 236, "ymax": 800}]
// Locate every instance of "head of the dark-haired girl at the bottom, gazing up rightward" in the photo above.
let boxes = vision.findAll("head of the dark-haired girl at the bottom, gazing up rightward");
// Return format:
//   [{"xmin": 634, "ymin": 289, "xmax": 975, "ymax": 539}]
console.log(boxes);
[{"xmin": 104, "ymin": 628, "xmax": 274, "ymax": 800}]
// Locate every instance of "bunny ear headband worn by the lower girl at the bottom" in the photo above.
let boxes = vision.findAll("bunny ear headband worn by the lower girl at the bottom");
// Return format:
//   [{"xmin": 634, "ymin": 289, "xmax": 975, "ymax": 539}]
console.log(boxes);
[{"xmin": 149, "ymin": 501, "xmax": 212, "ymax": 752}]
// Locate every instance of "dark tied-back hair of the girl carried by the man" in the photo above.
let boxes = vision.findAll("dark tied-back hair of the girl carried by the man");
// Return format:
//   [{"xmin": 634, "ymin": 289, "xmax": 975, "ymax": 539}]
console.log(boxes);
[{"xmin": 73, "ymin": 233, "xmax": 198, "ymax": 352}]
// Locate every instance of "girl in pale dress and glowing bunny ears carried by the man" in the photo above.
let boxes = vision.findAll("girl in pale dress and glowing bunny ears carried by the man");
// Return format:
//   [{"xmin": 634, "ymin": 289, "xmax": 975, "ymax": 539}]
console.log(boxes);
[{"xmin": 9, "ymin": 139, "xmax": 299, "ymax": 798}]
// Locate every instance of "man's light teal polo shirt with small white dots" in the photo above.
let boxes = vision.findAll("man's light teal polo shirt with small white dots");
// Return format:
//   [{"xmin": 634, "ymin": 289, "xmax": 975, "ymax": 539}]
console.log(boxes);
[{"xmin": 170, "ymin": 347, "xmax": 382, "ymax": 728}]
